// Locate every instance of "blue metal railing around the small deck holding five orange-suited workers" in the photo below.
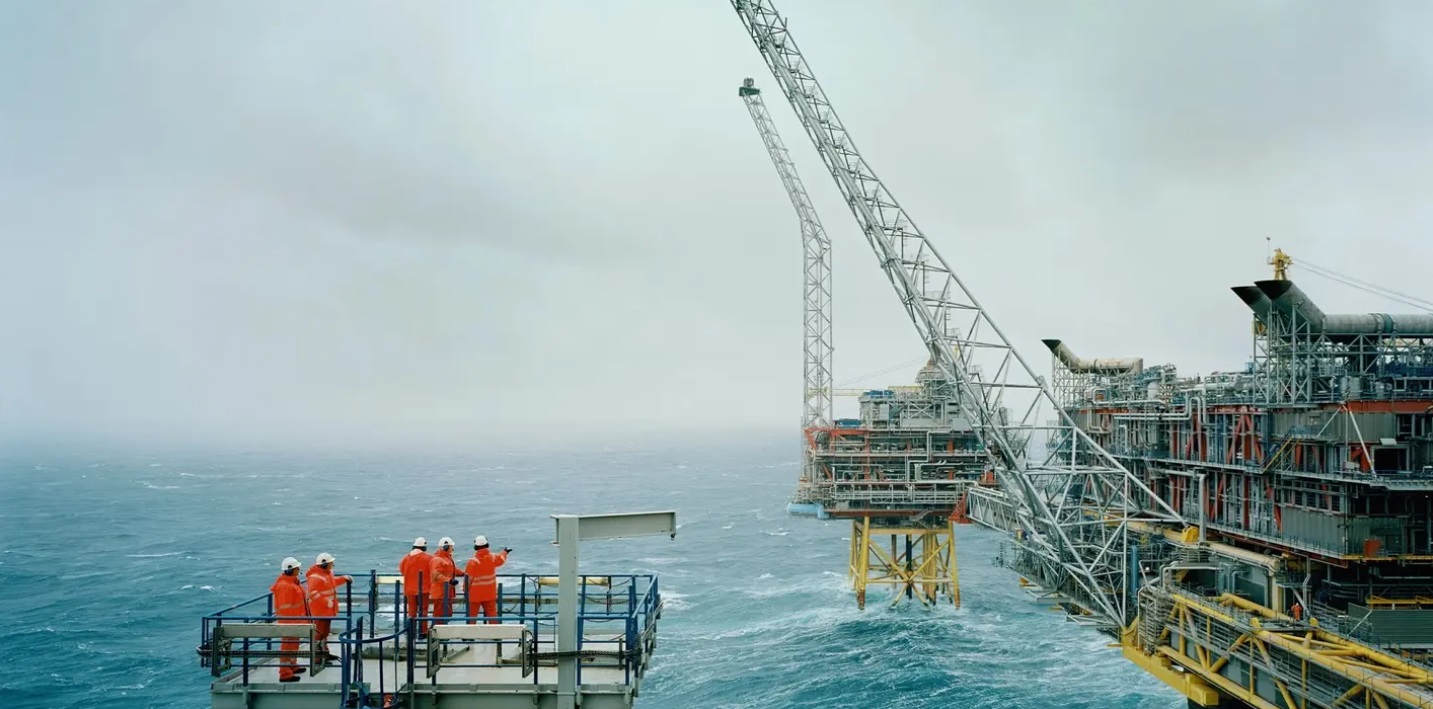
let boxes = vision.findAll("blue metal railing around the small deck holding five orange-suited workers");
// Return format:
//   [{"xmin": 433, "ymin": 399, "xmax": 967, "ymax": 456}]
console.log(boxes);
[{"xmin": 199, "ymin": 571, "xmax": 662, "ymax": 706}]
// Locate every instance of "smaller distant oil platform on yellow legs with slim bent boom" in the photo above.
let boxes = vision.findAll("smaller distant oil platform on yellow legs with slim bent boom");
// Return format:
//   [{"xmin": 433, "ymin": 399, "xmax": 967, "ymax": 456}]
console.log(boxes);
[{"xmin": 737, "ymin": 79, "xmax": 986, "ymax": 609}]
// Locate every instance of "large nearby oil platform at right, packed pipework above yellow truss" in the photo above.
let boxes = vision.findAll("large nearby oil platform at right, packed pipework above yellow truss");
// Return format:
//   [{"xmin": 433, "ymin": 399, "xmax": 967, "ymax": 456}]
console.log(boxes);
[{"xmin": 1026, "ymin": 251, "xmax": 1433, "ymax": 708}]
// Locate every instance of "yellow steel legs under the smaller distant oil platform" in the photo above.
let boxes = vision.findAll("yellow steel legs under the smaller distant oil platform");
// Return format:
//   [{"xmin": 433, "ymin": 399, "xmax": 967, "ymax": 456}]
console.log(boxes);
[{"xmin": 850, "ymin": 517, "xmax": 960, "ymax": 610}]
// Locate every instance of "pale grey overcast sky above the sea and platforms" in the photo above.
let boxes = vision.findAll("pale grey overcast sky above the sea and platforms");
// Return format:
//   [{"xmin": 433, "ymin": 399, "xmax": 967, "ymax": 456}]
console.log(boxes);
[{"xmin": 0, "ymin": 0, "xmax": 1433, "ymax": 443}]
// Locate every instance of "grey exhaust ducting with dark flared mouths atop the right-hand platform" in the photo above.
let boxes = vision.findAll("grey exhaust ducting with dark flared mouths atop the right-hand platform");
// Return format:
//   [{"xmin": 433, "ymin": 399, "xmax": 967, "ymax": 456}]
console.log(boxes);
[{"xmin": 1234, "ymin": 281, "xmax": 1433, "ymax": 337}]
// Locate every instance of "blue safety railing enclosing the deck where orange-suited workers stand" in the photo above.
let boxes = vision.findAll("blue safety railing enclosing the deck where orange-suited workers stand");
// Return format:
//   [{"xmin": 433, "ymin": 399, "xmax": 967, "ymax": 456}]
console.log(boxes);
[{"xmin": 198, "ymin": 571, "xmax": 662, "ymax": 706}]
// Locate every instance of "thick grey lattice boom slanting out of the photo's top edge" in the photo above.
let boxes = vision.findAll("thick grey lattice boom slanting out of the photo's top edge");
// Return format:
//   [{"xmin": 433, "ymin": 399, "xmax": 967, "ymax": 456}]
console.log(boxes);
[{"xmin": 731, "ymin": 0, "xmax": 1182, "ymax": 630}]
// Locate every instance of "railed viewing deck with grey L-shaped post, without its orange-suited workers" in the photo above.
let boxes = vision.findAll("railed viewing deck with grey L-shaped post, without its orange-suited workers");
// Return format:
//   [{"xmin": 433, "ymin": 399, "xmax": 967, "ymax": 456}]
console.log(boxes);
[{"xmin": 198, "ymin": 513, "xmax": 676, "ymax": 709}]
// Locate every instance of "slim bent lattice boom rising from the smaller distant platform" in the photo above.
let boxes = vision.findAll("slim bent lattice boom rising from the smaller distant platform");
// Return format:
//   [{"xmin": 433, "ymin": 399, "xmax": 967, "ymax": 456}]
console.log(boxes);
[{"xmin": 737, "ymin": 79, "xmax": 833, "ymax": 428}]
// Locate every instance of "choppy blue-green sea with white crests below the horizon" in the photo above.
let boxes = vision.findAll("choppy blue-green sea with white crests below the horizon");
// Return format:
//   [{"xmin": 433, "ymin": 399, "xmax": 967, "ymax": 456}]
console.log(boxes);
[{"xmin": 0, "ymin": 435, "xmax": 1185, "ymax": 709}]
